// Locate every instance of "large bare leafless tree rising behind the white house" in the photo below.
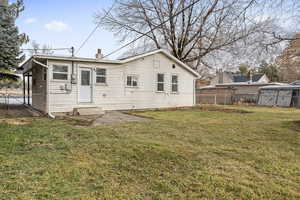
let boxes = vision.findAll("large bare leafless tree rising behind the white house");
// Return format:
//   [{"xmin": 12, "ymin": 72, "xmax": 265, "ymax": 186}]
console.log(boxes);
[{"xmin": 96, "ymin": 0, "xmax": 298, "ymax": 77}]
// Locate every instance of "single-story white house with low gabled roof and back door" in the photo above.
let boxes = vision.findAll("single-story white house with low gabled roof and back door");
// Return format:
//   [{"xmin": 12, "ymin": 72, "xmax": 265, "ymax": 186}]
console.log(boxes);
[{"xmin": 21, "ymin": 50, "xmax": 198, "ymax": 115}]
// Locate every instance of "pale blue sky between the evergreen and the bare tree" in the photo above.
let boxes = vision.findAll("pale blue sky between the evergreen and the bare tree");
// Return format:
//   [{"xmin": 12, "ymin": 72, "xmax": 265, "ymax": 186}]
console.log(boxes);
[{"xmin": 17, "ymin": 0, "xmax": 120, "ymax": 58}]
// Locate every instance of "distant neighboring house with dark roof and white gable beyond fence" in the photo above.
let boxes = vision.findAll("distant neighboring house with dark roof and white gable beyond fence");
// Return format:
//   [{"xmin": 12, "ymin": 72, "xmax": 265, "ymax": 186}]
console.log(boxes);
[{"xmin": 211, "ymin": 71, "xmax": 270, "ymax": 85}]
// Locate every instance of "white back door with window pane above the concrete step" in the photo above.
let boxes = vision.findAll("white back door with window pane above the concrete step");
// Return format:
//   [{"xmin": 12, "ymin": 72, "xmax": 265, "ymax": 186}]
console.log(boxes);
[{"xmin": 79, "ymin": 68, "xmax": 92, "ymax": 103}]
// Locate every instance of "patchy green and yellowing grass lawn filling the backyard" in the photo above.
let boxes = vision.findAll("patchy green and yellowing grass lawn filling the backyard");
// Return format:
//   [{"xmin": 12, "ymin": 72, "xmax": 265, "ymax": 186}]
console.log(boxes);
[{"xmin": 0, "ymin": 107, "xmax": 300, "ymax": 200}]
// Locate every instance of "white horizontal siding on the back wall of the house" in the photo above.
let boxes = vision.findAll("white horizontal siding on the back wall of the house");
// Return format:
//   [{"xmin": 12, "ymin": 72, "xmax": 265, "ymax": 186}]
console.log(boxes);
[{"xmin": 48, "ymin": 53, "xmax": 195, "ymax": 112}]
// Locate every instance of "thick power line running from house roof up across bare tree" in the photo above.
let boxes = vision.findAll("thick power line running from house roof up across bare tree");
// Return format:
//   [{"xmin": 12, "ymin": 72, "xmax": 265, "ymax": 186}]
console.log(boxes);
[{"xmin": 102, "ymin": 0, "xmax": 201, "ymax": 58}]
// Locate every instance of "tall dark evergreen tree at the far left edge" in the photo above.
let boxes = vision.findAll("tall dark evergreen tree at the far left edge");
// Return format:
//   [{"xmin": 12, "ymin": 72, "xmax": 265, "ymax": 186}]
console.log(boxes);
[{"xmin": 0, "ymin": 0, "xmax": 28, "ymax": 80}]
